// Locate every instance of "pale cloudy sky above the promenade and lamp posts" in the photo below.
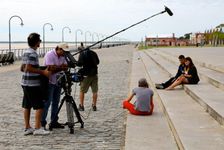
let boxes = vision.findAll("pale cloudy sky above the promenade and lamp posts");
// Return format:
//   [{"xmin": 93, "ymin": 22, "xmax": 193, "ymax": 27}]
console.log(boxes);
[{"xmin": 0, "ymin": 0, "xmax": 224, "ymax": 41}]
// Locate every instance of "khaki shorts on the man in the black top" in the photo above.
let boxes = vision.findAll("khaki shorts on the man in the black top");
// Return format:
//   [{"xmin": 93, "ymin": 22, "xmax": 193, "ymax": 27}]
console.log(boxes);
[{"xmin": 80, "ymin": 75, "xmax": 98, "ymax": 93}]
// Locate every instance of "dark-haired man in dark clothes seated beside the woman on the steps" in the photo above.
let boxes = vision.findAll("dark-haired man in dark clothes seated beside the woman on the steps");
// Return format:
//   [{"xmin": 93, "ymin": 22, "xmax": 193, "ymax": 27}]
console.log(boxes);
[{"xmin": 156, "ymin": 55, "xmax": 185, "ymax": 89}]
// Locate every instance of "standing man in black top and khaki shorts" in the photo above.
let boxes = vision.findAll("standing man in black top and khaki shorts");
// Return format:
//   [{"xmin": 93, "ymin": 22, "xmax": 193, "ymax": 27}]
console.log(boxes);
[{"xmin": 77, "ymin": 49, "xmax": 100, "ymax": 111}]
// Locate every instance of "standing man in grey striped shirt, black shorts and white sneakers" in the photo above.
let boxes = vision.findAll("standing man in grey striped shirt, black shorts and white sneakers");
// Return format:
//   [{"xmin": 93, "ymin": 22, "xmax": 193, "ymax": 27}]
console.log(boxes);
[{"xmin": 21, "ymin": 33, "xmax": 50, "ymax": 135}]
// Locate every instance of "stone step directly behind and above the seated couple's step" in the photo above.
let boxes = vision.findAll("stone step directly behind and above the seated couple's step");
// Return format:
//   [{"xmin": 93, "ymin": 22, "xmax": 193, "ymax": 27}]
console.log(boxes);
[{"xmin": 152, "ymin": 49, "xmax": 224, "ymax": 90}]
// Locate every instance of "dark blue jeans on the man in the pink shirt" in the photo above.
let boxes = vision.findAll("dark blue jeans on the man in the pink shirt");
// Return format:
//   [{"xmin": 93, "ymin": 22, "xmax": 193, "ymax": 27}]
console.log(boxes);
[{"xmin": 41, "ymin": 83, "xmax": 61, "ymax": 127}]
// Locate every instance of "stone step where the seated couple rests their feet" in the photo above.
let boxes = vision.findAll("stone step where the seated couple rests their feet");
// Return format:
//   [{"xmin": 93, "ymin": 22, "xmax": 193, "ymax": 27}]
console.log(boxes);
[{"xmin": 140, "ymin": 52, "xmax": 224, "ymax": 150}]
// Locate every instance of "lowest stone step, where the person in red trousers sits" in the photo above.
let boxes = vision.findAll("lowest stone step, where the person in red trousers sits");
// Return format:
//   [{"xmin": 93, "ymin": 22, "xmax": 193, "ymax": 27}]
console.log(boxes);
[{"xmin": 125, "ymin": 52, "xmax": 178, "ymax": 150}]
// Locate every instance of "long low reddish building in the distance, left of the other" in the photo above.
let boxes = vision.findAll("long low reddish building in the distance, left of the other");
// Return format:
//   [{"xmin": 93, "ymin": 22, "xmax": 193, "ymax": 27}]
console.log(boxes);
[{"xmin": 145, "ymin": 34, "xmax": 189, "ymax": 46}]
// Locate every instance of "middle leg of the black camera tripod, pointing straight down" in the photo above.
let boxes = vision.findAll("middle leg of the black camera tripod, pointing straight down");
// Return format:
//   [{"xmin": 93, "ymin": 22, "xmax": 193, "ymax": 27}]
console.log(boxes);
[{"xmin": 66, "ymin": 100, "xmax": 74, "ymax": 134}]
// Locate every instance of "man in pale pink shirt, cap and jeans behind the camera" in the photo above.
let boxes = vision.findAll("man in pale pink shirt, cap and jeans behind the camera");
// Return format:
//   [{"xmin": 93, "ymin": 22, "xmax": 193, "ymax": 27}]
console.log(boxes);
[{"xmin": 41, "ymin": 43, "xmax": 68, "ymax": 128}]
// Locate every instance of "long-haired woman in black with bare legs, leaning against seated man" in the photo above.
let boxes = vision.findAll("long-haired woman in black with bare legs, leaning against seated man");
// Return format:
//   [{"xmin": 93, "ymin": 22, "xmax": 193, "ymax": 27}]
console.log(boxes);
[{"xmin": 166, "ymin": 57, "xmax": 200, "ymax": 90}]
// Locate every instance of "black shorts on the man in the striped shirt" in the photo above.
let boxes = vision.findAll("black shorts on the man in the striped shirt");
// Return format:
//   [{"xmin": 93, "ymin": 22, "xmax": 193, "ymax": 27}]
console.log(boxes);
[{"xmin": 22, "ymin": 86, "xmax": 44, "ymax": 110}]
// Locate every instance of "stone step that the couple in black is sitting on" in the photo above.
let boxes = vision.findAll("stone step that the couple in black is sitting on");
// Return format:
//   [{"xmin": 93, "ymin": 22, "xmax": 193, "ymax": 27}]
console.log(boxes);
[{"xmin": 146, "ymin": 51, "xmax": 224, "ymax": 125}]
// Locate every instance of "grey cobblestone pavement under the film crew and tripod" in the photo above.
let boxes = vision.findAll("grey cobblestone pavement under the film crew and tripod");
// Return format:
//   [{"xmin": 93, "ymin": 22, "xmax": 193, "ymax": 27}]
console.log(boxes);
[{"xmin": 0, "ymin": 46, "xmax": 133, "ymax": 150}]
